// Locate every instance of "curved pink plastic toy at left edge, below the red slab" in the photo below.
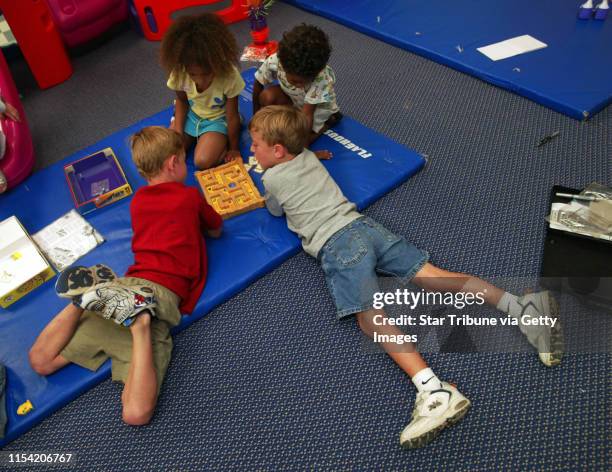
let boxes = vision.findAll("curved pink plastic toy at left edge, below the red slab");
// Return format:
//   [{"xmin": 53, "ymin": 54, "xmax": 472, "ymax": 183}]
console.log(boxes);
[{"xmin": 0, "ymin": 53, "xmax": 34, "ymax": 193}]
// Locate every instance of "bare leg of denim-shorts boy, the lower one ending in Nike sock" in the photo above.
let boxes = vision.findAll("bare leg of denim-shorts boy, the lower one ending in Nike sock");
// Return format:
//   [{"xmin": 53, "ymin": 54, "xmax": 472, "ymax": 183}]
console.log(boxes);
[{"xmin": 357, "ymin": 309, "xmax": 427, "ymax": 378}]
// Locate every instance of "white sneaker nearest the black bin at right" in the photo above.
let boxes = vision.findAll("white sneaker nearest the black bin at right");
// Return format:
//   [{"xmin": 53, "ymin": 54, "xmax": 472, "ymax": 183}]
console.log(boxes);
[{"xmin": 517, "ymin": 291, "xmax": 564, "ymax": 367}]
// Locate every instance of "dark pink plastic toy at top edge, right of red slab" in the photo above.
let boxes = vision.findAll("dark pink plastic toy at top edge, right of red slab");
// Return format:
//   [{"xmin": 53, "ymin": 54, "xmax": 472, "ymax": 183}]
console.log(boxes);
[{"xmin": 47, "ymin": 0, "xmax": 128, "ymax": 47}]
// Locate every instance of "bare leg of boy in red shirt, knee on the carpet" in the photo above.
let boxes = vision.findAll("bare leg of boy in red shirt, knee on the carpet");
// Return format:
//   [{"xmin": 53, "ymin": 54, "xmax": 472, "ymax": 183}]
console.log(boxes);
[{"xmin": 121, "ymin": 312, "xmax": 157, "ymax": 426}]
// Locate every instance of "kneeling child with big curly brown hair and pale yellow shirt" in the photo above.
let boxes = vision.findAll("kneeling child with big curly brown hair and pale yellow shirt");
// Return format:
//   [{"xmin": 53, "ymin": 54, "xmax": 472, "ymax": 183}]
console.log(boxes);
[{"xmin": 161, "ymin": 13, "xmax": 244, "ymax": 169}]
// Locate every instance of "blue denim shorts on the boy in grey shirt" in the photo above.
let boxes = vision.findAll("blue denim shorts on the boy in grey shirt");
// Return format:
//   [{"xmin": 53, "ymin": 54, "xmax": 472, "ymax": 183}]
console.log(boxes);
[{"xmin": 318, "ymin": 216, "xmax": 429, "ymax": 318}]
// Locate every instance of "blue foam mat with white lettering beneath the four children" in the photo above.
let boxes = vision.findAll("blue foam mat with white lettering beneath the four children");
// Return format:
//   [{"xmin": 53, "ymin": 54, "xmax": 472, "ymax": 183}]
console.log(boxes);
[{"xmin": 0, "ymin": 71, "xmax": 425, "ymax": 447}]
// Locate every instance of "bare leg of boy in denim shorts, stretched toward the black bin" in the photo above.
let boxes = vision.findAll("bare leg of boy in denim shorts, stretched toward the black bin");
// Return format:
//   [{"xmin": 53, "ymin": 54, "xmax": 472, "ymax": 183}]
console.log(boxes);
[{"xmin": 412, "ymin": 263, "xmax": 504, "ymax": 307}]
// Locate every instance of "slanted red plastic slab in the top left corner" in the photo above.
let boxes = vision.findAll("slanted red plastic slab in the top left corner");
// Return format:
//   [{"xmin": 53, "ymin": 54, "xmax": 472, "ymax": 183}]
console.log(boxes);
[{"xmin": 0, "ymin": 0, "xmax": 72, "ymax": 89}]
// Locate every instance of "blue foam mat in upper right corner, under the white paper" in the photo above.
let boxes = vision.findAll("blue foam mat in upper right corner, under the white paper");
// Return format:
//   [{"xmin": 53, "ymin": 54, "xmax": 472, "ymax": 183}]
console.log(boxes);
[{"xmin": 285, "ymin": 0, "xmax": 612, "ymax": 120}]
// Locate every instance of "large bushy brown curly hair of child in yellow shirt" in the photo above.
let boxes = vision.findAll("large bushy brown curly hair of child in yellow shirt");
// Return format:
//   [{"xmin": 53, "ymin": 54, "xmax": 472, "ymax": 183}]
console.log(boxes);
[{"xmin": 160, "ymin": 13, "xmax": 238, "ymax": 77}]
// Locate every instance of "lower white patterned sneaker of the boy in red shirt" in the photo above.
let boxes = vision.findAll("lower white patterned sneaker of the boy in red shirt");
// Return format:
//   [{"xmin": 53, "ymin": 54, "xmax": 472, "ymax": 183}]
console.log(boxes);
[{"xmin": 75, "ymin": 283, "xmax": 157, "ymax": 327}]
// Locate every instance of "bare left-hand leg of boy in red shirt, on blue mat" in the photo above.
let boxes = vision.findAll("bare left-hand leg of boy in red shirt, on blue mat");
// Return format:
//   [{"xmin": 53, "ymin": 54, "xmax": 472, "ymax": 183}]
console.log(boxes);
[{"xmin": 29, "ymin": 303, "xmax": 83, "ymax": 375}]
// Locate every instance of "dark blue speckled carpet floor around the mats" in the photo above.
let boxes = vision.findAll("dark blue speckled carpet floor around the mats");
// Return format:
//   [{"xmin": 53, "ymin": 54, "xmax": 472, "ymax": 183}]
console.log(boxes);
[{"xmin": 4, "ymin": 4, "xmax": 612, "ymax": 472}]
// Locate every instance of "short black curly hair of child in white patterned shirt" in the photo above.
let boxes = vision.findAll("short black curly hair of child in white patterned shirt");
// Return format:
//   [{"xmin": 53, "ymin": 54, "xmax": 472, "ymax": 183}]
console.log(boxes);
[{"xmin": 278, "ymin": 23, "xmax": 331, "ymax": 80}]
